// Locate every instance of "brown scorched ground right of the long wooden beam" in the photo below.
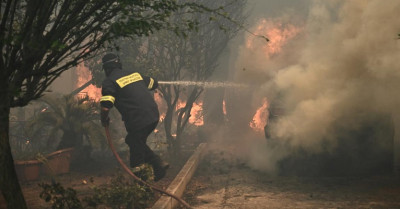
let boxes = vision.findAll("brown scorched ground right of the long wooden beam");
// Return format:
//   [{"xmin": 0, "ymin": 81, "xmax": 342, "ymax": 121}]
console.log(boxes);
[{"xmin": 184, "ymin": 151, "xmax": 400, "ymax": 209}]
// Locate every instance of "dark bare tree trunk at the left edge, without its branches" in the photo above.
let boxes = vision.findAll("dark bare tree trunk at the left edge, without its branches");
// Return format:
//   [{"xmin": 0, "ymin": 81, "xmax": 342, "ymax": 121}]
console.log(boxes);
[{"xmin": 0, "ymin": 97, "xmax": 27, "ymax": 209}]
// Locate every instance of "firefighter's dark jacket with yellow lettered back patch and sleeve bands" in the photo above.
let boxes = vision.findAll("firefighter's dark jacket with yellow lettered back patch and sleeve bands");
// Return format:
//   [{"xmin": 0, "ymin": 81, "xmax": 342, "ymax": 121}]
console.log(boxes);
[{"xmin": 100, "ymin": 69, "xmax": 159, "ymax": 130}]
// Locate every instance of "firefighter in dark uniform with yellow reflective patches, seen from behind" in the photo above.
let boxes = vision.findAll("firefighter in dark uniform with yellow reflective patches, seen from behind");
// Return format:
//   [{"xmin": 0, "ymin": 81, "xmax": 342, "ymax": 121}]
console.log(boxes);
[{"xmin": 100, "ymin": 53, "xmax": 169, "ymax": 181}]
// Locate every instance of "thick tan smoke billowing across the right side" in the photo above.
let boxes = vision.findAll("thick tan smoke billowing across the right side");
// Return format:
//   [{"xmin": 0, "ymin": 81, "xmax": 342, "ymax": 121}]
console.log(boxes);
[{"xmin": 231, "ymin": 0, "xmax": 400, "ymax": 173}]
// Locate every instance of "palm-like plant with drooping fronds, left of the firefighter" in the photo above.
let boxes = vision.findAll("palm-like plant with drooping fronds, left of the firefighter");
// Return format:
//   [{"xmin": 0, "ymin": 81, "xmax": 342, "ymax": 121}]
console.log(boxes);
[{"xmin": 28, "ymin": 95, "xmax": 106, "ymax": 152}]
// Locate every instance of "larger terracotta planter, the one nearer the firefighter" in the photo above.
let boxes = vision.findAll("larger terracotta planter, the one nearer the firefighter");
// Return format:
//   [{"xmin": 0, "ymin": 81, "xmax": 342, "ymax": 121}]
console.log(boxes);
[{"xmin": 44, "ymin": 148, "xmax": 74, "ymax": 175}]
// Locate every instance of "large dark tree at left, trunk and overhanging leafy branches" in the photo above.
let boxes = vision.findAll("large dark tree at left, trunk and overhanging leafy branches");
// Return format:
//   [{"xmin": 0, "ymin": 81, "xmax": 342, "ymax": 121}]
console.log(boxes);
[{"xmin": 0, "ymin": 0, "xmax": 225, "ymax": 208}]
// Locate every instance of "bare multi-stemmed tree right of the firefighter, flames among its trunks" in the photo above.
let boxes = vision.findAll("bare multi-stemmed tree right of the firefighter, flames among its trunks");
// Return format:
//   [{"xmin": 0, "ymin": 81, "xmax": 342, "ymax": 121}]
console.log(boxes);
[{"xmin": 138, "ymin": 0, "xmax": 246, "ymax": 154}]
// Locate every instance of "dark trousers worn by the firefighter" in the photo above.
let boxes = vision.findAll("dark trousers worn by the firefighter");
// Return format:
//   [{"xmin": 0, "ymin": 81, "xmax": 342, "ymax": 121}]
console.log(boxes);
[{"xmin": 125, "ymin": 121, "xmax": 159, "ymax": 168}]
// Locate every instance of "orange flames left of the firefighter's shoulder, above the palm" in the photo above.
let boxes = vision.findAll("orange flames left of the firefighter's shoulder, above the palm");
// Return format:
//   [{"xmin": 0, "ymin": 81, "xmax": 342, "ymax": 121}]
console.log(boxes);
[{"xmin": 75, "ymin": 63, "xmax": 101, "ymax": 101}]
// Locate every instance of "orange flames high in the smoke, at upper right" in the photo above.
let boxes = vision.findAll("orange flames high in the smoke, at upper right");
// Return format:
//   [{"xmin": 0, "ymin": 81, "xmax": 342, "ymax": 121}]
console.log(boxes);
[{"xmin": 246, "ymin": 19, "xmax": 300, "ymax": 58}]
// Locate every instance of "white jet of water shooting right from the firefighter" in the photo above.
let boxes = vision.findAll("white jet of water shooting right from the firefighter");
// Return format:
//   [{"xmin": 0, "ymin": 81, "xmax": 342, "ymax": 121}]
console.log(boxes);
[{"xmin": 158, "ymin": 81, "xmax": 248, "ymax": 88}]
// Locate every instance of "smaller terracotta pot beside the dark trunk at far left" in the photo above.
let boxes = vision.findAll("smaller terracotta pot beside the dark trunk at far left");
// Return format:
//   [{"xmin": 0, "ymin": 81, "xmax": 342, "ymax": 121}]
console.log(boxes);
[{"xmin": 14, "ymin": 160, "xmax": 42, "ymax": 181}]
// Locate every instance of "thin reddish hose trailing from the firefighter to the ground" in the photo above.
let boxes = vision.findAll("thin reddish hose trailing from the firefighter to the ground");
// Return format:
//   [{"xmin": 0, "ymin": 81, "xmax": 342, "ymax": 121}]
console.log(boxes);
[{"xmin": 104, "ymin": 126, "xmax": 192, "ymax": 209}]
